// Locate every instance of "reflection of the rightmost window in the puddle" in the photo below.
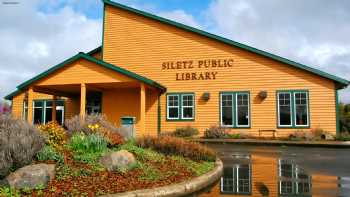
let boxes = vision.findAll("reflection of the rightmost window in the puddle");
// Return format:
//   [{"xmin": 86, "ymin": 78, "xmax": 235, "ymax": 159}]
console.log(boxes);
[{"xmin": 279, "ymin": 159, "xmax": 311, "ymax": 196}]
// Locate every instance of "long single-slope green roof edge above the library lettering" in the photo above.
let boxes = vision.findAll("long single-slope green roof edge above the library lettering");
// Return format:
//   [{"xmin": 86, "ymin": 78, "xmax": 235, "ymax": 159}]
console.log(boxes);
[{"xmin": 102, "ymin": 0, "xmax": 350, "ymax": 88}]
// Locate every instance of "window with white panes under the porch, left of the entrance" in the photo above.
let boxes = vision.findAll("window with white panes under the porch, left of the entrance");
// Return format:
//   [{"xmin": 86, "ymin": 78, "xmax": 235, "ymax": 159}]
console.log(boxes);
[{"xmin": 33, "ymin": 100, "xmax": 64, "ymax": 125}]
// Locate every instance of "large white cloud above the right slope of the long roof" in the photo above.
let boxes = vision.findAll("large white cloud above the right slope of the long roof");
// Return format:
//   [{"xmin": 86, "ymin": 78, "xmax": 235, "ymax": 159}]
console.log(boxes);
[{"xmin": 206, "ymin": 0, "xmax": 350, "ymax": 102}]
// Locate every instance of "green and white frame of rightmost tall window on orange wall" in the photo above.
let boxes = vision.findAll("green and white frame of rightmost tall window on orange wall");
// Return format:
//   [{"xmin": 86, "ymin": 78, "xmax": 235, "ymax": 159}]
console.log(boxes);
[{"xmin": 275, "ymin": 90, "xmax": 311, "ymax": 129}]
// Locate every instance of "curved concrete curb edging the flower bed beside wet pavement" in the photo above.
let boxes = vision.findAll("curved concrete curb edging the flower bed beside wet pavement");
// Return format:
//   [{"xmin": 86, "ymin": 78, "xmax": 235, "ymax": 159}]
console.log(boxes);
[{"xmin": 100, "ymin": 159, "xmax": 223, "ymax": 197}]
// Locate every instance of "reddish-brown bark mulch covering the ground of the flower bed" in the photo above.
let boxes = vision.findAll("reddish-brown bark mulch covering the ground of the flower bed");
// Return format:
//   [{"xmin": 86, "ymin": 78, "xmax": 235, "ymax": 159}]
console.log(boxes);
[{"xmin": 28, "ymin": 152, "xmax": 195, "ymax": 196}]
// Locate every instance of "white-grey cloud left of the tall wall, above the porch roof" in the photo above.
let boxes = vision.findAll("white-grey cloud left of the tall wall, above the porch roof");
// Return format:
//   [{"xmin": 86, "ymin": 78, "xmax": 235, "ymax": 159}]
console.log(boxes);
[{"xmin": 0, "ymin": 0, "xmax": 102, "ymax": 100}]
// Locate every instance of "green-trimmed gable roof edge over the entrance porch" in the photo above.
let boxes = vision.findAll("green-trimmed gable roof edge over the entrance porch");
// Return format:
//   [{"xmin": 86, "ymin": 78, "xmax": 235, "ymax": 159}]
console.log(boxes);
[{"xmin": 5, "ymin": 52, "xmax": 166, "ymax": 100}]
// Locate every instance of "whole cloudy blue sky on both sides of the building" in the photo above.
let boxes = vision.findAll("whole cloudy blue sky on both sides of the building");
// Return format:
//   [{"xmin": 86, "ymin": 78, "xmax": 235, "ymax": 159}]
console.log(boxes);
[{"xmin": 0, "ymin": 0, "xmax": 350, "ymax": 103}]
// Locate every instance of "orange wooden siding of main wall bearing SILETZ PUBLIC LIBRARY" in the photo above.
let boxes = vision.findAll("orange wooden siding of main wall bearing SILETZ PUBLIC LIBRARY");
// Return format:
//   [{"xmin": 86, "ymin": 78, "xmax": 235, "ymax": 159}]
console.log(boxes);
[{"xmin": 103, "ymin": 5, "xmax": 336, "ymax": 136}]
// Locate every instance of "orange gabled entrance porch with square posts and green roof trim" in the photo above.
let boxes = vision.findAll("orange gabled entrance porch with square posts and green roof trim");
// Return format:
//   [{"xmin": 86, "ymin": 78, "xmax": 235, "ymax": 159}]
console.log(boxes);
[{"xmin": 17, "ymin": 53, "xmax": 165, "ymax": 135}]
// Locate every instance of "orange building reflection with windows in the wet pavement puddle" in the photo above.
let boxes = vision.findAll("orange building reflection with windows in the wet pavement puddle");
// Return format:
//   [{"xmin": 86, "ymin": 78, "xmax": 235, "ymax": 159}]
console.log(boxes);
[{"xmin": 199, "ymin": 154, "xmax": 350, "ymax": 197}]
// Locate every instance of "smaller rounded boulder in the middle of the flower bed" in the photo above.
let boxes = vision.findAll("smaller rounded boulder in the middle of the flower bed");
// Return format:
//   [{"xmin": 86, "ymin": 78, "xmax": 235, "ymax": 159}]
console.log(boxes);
[{"xmin": 100, "ymin": 150, "xmax": 136, "ymax": 171}]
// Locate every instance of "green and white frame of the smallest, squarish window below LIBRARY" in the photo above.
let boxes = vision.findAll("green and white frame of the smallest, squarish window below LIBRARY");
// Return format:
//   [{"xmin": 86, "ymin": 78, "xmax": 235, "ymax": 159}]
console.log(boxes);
[{"xmin": 166, "ymin": 92, "xmax": 196, "ymax": 121}]
